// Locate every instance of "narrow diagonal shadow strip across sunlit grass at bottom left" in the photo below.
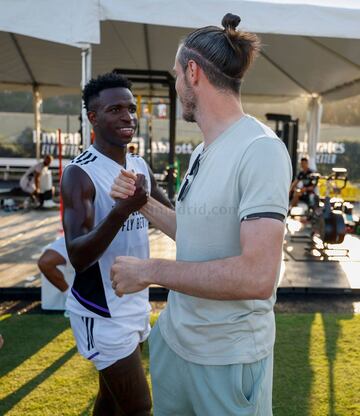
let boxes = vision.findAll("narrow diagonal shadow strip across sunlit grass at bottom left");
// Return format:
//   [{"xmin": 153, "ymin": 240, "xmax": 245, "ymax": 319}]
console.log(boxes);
[{"xmin": 0, "ymin": 347, "xmax": 77, "ymax": 414}]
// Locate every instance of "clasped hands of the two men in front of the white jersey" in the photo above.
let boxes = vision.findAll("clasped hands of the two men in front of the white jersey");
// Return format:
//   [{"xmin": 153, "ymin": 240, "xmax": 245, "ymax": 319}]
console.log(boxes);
[{"xmin": 110, "ymin": 170, "xmax": 149, "ymax": 215}]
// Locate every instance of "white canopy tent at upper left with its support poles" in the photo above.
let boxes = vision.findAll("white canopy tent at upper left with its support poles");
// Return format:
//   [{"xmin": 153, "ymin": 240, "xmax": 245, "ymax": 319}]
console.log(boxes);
[{"xmin": 0, "ymin": 0, "xmax": 100, "ymax": 158}]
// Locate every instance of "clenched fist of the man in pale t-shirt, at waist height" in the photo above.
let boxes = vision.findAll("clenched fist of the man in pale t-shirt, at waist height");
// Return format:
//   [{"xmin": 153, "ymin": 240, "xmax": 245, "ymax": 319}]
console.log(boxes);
[{"xmin": 110, "ymin": 256, "xmax": 150, "ymax": 296}]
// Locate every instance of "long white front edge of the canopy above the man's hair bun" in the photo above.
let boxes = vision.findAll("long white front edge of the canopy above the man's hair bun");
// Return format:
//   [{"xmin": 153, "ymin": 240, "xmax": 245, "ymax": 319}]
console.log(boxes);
[{"xmin": 99, "ymin": 0, "xmax": 360, "ymax": 38}]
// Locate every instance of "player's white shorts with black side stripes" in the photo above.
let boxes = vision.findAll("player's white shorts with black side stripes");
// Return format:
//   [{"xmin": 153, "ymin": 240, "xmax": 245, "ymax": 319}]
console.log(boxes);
[{"xmin": 69, "ymin": 312, "xmax": 150, "ymax": 371}]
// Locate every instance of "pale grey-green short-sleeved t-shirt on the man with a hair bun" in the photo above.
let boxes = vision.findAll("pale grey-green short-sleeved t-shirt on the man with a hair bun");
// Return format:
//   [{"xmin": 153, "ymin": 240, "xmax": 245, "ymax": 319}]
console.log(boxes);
[{"xmin": 159, "ymin": 115, "xmax": 292, "ymax": 365}]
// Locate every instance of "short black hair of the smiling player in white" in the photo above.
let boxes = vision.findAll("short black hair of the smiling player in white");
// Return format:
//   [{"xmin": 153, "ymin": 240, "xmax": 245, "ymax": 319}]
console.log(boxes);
[{"xmin": 82, "ymin": 72, "xmax": 131, "ymax": 111}]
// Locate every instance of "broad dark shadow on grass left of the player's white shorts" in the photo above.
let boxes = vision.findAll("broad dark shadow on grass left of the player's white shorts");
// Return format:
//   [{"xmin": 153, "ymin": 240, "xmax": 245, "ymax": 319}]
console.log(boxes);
[{"xmin": 0, "ymin": 314, "xmax": 69, "ymax": 378}]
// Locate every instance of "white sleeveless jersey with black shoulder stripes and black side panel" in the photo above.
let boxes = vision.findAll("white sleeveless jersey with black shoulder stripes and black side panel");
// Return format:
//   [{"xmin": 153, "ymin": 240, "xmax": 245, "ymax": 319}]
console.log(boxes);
[{"xmin": 66, "ymin": 146, "xmax": 151, "ymax": 318}]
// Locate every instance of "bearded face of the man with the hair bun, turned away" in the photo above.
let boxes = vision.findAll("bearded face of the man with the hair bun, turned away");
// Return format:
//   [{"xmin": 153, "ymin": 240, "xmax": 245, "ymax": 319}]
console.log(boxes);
[{"xmin": 174, "ymin": 49, "xmax": 197, "ymax": 123}]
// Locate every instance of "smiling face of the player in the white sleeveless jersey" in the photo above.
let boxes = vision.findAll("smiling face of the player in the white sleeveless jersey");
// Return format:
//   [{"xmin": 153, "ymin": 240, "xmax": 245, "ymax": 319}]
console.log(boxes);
[{"xmin": 88, "ymin": 88, "xmax": 137, "ymax": 147}]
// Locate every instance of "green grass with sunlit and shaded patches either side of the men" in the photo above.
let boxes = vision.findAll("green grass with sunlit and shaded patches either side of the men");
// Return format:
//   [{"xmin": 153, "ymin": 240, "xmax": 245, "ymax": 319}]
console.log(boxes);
[{"xmin": 0, "ymin": 314, "xmax": 360, "ymax": 416}]
